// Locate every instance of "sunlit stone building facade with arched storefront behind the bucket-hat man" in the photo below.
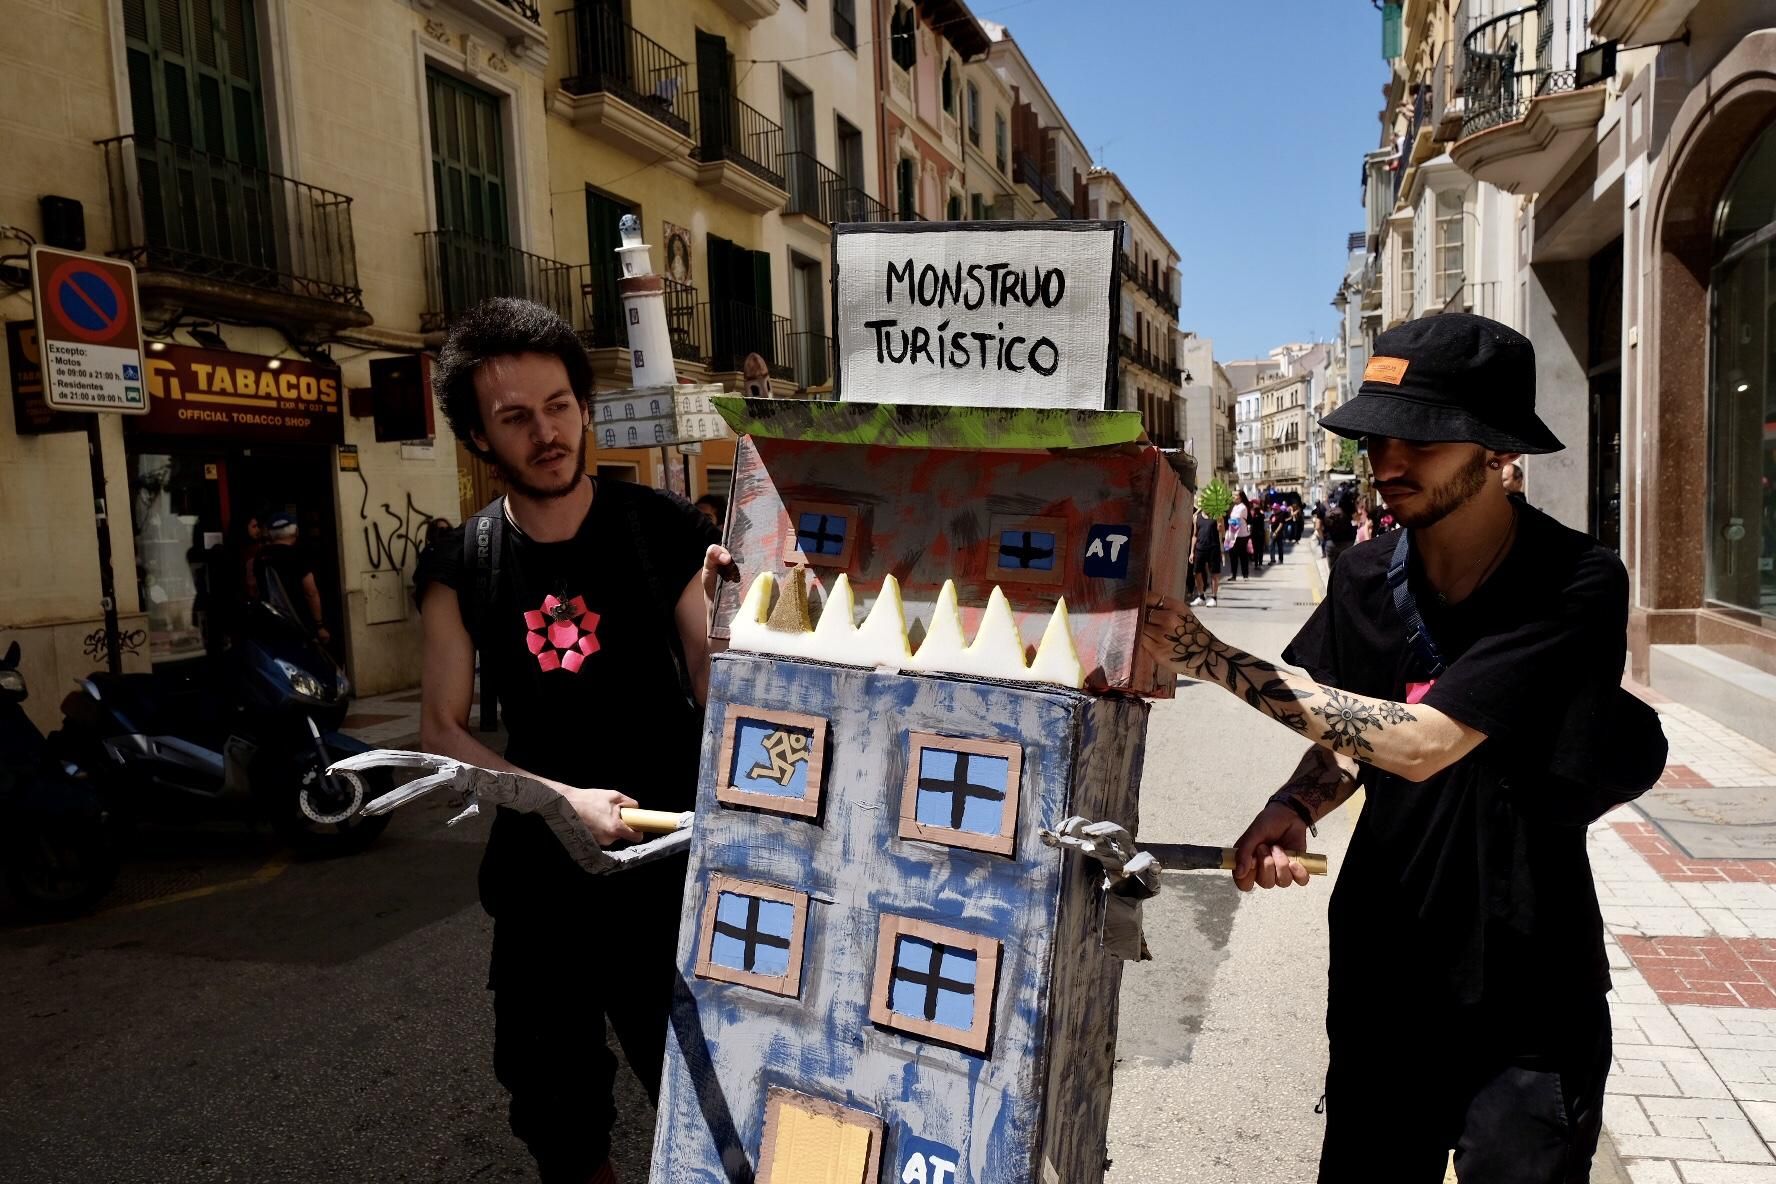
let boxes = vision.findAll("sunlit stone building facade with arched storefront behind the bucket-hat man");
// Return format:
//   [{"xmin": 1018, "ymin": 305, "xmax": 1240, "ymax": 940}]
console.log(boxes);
[{"xmin": 1355, "ymin": 0, "xmax": 1776, "ymax": 742}]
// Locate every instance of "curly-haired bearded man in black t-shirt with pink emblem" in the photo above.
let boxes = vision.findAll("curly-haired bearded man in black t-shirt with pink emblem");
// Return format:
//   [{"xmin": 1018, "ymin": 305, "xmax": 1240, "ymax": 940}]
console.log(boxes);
[{"xmin": 414, "ymin": 298, "xmax": 732, "ymax": 1184}]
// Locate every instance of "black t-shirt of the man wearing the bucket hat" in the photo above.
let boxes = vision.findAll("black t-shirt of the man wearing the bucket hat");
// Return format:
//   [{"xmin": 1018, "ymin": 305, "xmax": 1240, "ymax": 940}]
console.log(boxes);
[{"xmin": 1284, "ymin": 506, "xmax": 1664, "ymax": 1031}]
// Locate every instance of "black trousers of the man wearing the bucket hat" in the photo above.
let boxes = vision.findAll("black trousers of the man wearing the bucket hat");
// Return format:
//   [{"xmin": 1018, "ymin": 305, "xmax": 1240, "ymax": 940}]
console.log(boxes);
[{"xmin": 1320, "ymin": 996, "xmax": 1609, "ymax": 1184}]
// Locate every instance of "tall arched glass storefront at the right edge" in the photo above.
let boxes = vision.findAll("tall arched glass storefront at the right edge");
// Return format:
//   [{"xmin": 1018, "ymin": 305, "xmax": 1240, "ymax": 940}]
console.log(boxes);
[{"xmin": 1704, "ymin": 128, "xmax": 1776, "ymax": 625}]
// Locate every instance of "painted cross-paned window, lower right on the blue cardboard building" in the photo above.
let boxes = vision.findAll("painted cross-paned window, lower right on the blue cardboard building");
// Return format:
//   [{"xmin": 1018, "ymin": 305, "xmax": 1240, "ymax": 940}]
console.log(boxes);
[{"xmin": 870, "ymin": 914, "xmax": 1000, "ymax": 1053}]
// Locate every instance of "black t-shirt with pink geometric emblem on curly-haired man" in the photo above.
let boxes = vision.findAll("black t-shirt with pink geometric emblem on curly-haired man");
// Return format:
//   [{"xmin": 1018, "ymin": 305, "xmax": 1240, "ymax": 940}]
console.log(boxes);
[{"xmin": 414, "ymin": 481, "xmax": 719, "ymax": 916}]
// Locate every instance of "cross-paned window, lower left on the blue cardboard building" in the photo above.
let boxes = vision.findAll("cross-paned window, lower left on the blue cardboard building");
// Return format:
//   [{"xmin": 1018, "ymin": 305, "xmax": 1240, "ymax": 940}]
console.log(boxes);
[{"xmin": 696, "ymin": 875, "xmax": 808, "ymax": 998}]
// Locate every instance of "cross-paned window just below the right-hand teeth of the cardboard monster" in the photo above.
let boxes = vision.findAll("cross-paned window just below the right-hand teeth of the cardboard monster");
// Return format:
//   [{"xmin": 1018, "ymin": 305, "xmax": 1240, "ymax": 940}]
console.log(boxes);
[{"xmin": 900, "ymin": 731, "xmax": 1023, "ymax": 856}]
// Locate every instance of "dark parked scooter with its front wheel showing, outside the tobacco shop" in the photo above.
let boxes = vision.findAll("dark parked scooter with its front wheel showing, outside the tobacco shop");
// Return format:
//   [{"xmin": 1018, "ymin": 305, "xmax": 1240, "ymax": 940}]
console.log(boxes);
[{"xmin": 59, "ymin": 570, "xmax": 389, "ymax": 854}]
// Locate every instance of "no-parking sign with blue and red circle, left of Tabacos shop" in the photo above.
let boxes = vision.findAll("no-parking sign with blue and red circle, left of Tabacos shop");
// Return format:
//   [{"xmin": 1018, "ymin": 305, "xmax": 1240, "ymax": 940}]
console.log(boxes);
[{"xmin": 30, "ymin": 247, "xmax": 147, "ymax": 415}]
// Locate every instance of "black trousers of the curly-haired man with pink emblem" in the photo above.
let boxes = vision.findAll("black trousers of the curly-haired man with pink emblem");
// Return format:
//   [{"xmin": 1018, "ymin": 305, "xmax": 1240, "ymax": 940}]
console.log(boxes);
[{"xmin": 488, "ymin": 859, "xmax": 684, "ymax": 1184}]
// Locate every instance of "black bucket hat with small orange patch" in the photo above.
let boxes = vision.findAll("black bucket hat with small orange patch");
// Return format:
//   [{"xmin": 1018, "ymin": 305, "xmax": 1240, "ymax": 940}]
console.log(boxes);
[{"xmin": 1320, "ymin": 312, "xmax": 1566, "ymax": 453}]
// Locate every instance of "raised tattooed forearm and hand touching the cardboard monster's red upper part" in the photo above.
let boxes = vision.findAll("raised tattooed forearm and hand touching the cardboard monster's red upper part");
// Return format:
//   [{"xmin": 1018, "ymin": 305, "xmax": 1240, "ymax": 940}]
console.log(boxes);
[{"xmin": 1142, "ymin": 605, "xmax": 1487, "ymax": 781}]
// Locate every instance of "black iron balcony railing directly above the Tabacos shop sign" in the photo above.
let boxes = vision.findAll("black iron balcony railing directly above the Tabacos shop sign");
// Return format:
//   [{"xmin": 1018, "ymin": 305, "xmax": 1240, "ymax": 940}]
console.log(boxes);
[{"xmin": 98, "ymin": 135, "xmax": 364, "ymax": 309}]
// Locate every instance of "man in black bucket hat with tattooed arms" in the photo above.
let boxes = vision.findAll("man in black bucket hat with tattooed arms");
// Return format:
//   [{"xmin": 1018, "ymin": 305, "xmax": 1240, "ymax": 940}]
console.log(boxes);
[{"xmin": 1144, "ymin": 314, "xmax": 1666, "ymax": 1184}]
